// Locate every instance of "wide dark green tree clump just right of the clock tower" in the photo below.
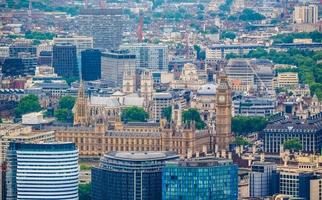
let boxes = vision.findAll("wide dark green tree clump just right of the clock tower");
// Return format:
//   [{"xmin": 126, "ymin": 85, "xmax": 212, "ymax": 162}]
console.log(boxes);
[{"xmin": 231, "ymin": 116, "xmax": 267, "ymax": 135}]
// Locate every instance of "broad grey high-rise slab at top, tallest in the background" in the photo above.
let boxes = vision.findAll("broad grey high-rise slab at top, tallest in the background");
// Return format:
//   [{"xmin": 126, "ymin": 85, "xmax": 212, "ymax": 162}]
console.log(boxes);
[{"xmin": 76, "ymin": 9, "xmax": 127, "ymax": 50}]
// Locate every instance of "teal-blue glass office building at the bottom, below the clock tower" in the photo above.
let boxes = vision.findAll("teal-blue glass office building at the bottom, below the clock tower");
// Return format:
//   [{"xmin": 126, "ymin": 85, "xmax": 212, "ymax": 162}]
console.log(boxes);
[{"xmin": 162, "ymin": 157, "xmax": 238, "ymax": 200}]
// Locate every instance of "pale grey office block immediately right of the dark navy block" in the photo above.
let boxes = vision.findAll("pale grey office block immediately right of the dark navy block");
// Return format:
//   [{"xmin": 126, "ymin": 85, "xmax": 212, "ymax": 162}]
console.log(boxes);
[{"xmin": 101, "ymin": 50, "xmax": 136, "ymax": 87}]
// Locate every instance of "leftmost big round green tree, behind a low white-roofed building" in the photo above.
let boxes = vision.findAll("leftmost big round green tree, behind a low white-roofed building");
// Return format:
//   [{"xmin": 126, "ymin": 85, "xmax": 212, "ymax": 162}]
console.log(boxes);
[{"xmin": 15, "ymin": 94, "xmax": 41, "ymax": 118}]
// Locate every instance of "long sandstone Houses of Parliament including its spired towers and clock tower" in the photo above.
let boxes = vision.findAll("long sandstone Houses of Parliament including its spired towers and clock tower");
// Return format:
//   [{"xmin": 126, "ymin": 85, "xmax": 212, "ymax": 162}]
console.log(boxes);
[{"xmin": 53, "ymin": 69, "xmax": 232, "ymax": 157}]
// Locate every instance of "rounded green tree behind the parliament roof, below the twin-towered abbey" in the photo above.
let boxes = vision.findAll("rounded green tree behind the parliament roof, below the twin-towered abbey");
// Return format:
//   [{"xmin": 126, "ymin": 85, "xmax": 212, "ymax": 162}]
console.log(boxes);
[{"xmin": 121, "ymin": 106, "xmax": 149, "ymax": 122}]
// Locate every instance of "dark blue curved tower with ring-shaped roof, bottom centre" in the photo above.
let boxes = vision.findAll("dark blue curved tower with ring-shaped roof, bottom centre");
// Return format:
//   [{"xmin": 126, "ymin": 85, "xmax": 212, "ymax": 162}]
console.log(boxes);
[{"xmin": 92, "ymin": 151, "xmax": 179, "ymax": 200}]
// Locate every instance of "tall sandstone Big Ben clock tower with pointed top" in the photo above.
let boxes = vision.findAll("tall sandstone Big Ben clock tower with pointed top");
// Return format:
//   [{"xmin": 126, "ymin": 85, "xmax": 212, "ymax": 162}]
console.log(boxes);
[{"xmin": 215, "ymin": 71, "xmax": 232, "ymax": 150}]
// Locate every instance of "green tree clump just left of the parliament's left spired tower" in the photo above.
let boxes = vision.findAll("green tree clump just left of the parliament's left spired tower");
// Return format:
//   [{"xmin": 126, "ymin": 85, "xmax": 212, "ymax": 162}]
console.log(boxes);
[{"xmin": 54, "ymin": 96, "xmax": 76, "ymax": 123}]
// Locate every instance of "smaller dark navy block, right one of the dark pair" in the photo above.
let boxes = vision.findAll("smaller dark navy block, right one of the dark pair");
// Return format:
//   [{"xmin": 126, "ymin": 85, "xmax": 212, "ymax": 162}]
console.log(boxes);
[{"xmin": 81, "ymin": 49, "xmax": 101, "ymax": 81}]
